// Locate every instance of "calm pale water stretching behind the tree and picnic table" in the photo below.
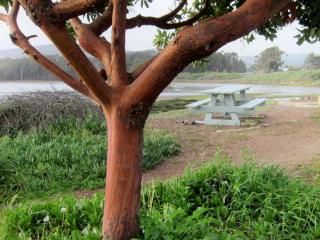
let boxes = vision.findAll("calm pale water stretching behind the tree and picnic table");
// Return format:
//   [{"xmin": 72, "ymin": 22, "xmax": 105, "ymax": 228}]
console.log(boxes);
[{"xmin": 0, "ymin": 81, "xmax": 320, "ymax": 97}]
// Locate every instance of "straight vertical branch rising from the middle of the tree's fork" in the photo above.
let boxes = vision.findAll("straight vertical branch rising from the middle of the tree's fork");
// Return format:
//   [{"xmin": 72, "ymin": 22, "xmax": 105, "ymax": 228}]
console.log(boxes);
[{"xmin": 111, "ymin": 0, "xmax": 128, "ymax": 85}]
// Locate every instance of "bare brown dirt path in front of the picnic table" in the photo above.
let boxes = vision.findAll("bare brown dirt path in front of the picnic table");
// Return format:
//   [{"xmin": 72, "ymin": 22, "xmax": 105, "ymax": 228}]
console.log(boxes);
[{"xmin": 143, "ymin": 104, "xmax": 320, "ymax": 182}]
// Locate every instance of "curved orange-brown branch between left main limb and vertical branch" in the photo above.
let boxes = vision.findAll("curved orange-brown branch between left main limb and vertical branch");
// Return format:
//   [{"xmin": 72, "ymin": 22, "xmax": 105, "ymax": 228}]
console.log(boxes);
[{"xmin": 69, "ymin": 18, "xmax": 112, "ymax": 77}]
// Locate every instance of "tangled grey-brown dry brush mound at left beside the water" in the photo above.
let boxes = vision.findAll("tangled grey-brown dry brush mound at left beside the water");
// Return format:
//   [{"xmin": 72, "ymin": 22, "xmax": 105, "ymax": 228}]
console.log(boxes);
[{"xmin": 0, "ymin": 92, "xmax": 102, "ymax": 136}]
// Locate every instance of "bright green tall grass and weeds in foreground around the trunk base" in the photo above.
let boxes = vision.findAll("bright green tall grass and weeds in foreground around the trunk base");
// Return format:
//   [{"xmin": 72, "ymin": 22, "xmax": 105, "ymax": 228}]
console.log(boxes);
[{"xmin": 0, "ymin": 156, "xmax": 320, "ymax": 240}]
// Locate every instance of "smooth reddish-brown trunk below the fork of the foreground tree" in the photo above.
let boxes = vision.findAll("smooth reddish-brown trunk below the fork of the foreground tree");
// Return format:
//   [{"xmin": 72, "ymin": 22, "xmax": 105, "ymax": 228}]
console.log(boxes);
[{"xmin": 103, "ymin": 110, "xmax": 143, "ymax": 240}]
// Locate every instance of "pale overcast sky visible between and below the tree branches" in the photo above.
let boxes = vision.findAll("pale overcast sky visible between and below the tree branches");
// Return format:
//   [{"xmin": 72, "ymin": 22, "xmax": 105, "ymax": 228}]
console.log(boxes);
[{"xmin": 0, "ymin": 0, "xmax": 320, "ymax": 56}]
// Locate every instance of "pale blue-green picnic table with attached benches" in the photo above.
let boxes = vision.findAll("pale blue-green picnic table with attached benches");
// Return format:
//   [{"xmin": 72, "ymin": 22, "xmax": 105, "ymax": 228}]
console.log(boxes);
[{"xmin": 187, "ymin": 85, "xmax": 267, "ymax": 126}]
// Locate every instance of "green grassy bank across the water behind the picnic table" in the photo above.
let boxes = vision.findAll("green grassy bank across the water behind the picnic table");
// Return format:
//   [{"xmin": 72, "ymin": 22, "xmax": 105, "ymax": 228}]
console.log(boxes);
[{"xmin": 176, "ymin": 70, "xmax": 320, "ymax": 86}]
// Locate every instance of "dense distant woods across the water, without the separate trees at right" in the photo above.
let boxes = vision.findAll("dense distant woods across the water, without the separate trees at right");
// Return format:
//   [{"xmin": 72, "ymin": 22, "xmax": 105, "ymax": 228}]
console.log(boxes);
[{"xmin": 0, "ymin": 51, "xmax": 247, "ymax": 81}]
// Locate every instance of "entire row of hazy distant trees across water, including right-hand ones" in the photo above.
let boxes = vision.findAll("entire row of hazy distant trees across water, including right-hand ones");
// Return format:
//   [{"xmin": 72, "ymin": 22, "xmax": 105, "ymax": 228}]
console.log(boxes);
[{"xmin": 0, "ymin": 47, "xmax": 320, "ymax": 81}]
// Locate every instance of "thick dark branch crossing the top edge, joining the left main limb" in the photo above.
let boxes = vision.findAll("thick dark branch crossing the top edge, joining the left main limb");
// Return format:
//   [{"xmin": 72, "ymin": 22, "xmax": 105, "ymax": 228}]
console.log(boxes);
[{"xmin": 52, "ymin": 0, "xmax": 101, "ymax": 21}]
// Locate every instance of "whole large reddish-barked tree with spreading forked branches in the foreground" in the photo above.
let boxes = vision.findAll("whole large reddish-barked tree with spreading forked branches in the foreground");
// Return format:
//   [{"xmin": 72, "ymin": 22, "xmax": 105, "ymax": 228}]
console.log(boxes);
[{"xmin": 0, "ymin": 0, "xmax": 320, "ymax": 239}]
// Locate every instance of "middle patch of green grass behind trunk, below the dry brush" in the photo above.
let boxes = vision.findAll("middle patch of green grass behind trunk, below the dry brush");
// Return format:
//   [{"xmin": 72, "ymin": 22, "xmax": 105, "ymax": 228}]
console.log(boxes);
[{"xmin": 0, "ymin": 115, "xmax": 180, "ymax": 202}]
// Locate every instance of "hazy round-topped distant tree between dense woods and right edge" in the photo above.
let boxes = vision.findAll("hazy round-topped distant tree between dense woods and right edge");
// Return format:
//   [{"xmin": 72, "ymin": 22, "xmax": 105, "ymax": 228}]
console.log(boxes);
[{"xmin": 252, "ymin": 47, "xmax": 284, "ymax": 73}]
